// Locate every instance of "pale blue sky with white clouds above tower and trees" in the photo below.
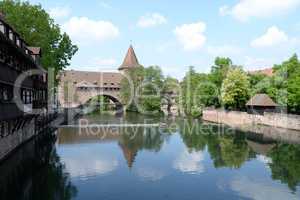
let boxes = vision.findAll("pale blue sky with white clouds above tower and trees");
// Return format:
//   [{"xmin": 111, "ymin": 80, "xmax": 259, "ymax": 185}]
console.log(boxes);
[{"xmin": 30, "ymin": 0, "xmax": 300, "ymax": 79}]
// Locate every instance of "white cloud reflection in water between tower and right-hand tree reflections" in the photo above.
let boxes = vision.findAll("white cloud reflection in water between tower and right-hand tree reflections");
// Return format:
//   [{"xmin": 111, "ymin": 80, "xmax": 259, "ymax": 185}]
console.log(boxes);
[{"xmin": 174, "ymin": 150, "xmax": 204, "ymax": 174}]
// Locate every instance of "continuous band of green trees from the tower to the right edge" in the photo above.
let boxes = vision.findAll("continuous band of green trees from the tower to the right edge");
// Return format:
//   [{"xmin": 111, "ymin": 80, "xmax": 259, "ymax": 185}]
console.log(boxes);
[{"xmin": 121, "ymin": 55, "xmax": 300, "ymax": 115}]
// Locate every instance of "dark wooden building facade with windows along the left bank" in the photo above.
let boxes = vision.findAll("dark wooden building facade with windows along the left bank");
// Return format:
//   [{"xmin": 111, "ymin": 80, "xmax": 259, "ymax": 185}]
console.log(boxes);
[{"xmin": 0, "ymin": 13, "xmax": 47, "ymax": 138}]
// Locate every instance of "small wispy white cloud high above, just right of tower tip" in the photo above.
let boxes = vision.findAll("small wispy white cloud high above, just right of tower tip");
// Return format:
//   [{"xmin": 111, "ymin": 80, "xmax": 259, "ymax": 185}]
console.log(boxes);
[{"xmin": 137, "ymin": 13, "xmax": 167, "ymax": 28}]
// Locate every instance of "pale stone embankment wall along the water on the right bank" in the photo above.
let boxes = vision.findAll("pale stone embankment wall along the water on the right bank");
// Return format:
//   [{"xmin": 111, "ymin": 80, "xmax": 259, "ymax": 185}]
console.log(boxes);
[{"xmin": 203, "ymin": 110, "xmax": 300, "ymax": 131}]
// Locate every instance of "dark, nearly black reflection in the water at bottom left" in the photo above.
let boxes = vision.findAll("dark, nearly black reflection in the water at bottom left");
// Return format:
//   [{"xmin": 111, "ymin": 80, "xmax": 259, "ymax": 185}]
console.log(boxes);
[{"xmin": 0, "ymin": 132, "xmax": 77, "ymax": 200}]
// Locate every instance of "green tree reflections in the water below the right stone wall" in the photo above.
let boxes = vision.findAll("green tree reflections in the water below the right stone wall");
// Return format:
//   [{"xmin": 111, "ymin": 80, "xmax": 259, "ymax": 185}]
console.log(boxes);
[{"xmin": 179, "ymin": 120, "xmax": 300, "ymax": 192}]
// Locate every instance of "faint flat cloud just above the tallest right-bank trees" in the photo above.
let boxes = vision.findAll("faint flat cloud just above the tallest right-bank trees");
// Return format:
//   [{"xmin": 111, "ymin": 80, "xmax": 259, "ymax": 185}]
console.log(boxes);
[{"xmin": 207, "ymin": 45, "xmax": 242, "ymax": 56}]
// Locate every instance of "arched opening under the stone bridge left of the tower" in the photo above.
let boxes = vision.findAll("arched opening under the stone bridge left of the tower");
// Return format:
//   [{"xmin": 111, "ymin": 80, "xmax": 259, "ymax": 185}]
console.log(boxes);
[{"xmin": 80, "ymin": 94, "xmax": 123, "ymax": 114}]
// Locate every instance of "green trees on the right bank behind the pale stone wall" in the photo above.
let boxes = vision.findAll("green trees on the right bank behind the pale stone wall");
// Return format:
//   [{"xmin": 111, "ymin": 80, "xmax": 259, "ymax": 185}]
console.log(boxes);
[{"xmin": 181, "ymin": 55, "xmax": 300, "ymax": 117}]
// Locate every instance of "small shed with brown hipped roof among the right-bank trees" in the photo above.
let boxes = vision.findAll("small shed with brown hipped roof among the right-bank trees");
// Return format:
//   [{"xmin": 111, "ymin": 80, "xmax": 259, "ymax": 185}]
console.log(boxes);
[{"xmin": 246, "ymin": 94, "xmax": 278, "ymax": 115}]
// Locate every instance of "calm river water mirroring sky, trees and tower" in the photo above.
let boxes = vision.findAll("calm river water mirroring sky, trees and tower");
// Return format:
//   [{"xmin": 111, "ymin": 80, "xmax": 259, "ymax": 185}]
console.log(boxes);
[{"xmin": 0, "ymin": 115, "xmax": 300, "ymax": 200}]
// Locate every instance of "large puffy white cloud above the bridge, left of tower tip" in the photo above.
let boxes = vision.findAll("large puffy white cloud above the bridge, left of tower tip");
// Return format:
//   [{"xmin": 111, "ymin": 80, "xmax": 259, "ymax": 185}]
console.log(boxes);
[{"xmin": 63, "ymin": 17, "xmax": 120, "ymax": 44}]
